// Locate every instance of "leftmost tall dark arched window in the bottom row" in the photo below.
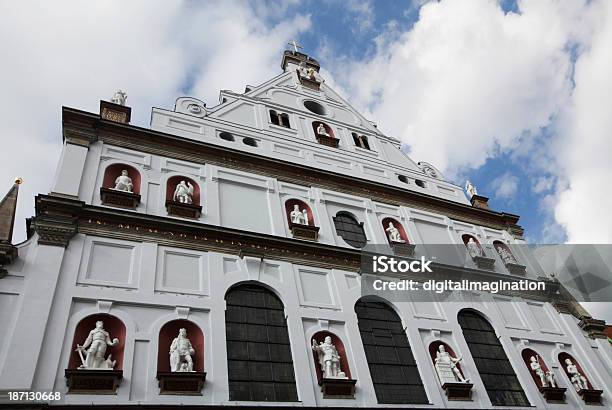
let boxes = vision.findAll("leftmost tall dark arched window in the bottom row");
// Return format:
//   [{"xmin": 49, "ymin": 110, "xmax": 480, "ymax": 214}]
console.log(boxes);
[{"xmin": 225, "ymin": 284, "xmax": 298, "ymax": 401}]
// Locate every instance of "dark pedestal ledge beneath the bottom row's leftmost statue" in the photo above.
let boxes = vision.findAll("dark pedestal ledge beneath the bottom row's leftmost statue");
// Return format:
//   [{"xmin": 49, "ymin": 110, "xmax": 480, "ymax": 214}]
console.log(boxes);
[{"xmin": 64, "ymin": 369, "xmax": 123, "ymax": 394}]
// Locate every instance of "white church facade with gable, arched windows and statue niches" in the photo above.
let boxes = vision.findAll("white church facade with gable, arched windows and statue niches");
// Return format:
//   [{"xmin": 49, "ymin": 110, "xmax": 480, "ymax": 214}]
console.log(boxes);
[{"xmin": 0, "ymin": 51, "xmax": 612, "ymax": 409}]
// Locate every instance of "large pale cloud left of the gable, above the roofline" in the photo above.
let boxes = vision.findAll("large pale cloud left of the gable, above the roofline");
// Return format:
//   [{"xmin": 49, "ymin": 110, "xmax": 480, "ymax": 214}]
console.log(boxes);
[{"xmin": 0, "ymin": 0, "xmax": 310, "ymax": 240}]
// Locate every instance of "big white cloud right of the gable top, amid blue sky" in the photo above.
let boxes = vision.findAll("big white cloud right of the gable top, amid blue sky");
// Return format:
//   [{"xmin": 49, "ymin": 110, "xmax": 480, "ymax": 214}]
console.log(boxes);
[{"xmin": 337, "ymin": 1, "xmax": 579, "ymax": 175}]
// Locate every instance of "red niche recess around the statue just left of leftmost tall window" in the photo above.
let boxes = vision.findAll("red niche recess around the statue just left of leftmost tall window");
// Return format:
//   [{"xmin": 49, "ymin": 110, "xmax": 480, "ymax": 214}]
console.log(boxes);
[{"xmin": 157, "ymin": 319, "xmax": 204, "ymax": 372}]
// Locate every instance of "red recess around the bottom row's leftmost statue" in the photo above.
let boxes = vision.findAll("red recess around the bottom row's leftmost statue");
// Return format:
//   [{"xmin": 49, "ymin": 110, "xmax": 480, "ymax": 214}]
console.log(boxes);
[{"xmin": 68, "ymin": 313, "xmax": 126, "ymax": 370}]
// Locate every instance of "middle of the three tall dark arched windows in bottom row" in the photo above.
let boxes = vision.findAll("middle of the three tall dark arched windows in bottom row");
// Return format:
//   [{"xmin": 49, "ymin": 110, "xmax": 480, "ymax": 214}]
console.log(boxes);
[{"xmin": 355, "ymin": 299, "xmax": 428, "ymax": 404}]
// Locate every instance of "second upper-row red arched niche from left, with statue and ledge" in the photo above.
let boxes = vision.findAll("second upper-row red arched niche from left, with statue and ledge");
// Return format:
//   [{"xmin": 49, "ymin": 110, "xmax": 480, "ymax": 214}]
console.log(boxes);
[{"xmin": 166, "ymin": 175, "xmax": 202, "ymax": 219}]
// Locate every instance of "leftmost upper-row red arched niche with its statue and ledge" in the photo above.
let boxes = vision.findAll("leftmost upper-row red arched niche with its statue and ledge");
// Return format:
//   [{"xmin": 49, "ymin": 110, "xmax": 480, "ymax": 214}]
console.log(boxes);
[{"xmin": 100, "ymin": 164, "xmax": 140, "ymax": 209}]
